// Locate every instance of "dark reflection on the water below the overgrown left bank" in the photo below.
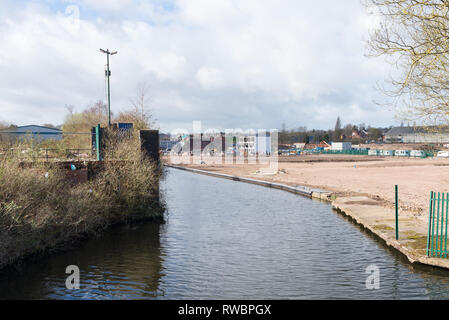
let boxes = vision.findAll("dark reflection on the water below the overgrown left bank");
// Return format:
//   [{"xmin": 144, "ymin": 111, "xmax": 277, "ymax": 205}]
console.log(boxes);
[{"xmin": 0, "ymin": 223, "xmax": 163, "ymax": 299}]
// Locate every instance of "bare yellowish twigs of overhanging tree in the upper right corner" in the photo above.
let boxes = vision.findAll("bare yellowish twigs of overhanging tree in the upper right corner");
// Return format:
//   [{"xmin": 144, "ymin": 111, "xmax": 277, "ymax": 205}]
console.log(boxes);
[{"xmin": 363, "ymin": 0, "xmax": 449, "ymax": 124}]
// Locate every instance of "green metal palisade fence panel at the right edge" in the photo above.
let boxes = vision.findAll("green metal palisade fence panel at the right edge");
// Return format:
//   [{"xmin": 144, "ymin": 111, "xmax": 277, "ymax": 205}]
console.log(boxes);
[{"xmin": 427, "ymin": 192, "xmax": 449, "ymax": 258}]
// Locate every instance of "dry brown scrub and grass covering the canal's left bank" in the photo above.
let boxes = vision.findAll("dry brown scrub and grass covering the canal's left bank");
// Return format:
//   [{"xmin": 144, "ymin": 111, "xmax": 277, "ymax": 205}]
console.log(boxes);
[{"xmin": 0, "ymin": 130, "xmax": 162, "ymax": 268}]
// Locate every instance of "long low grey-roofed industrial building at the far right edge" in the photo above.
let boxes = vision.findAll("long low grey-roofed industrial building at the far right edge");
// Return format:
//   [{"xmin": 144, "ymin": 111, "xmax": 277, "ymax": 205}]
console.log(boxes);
[{"xmin": 384, "ymin": 127, "xmax": 449, "ymax": 144}]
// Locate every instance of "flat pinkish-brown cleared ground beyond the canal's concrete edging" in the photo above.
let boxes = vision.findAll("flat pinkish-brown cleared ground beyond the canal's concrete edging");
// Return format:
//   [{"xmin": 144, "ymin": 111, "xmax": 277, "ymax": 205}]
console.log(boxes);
[{"xmin": 166, "ymin": 155, "xmax": 449, "ymax": 216}]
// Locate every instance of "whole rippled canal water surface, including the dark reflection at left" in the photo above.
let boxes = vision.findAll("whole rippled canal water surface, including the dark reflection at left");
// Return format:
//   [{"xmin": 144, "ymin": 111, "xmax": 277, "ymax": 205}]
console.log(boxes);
[{"xmin": 0, "ymin": 169, "xmax": 449, "ymax": 299}]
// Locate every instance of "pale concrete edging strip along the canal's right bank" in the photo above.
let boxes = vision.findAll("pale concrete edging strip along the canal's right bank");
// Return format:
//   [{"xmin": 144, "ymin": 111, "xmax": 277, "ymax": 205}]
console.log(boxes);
[{"xmin": 164, "ymin": 164, "xmax": 449, "ymax": 269}]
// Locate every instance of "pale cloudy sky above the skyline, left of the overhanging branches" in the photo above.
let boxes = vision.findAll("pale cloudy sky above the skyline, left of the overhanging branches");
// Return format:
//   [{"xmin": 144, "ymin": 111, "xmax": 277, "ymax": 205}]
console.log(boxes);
[{"xmin": 0, "ymin": 0, "xmax": 396, "ymax": 131}]
